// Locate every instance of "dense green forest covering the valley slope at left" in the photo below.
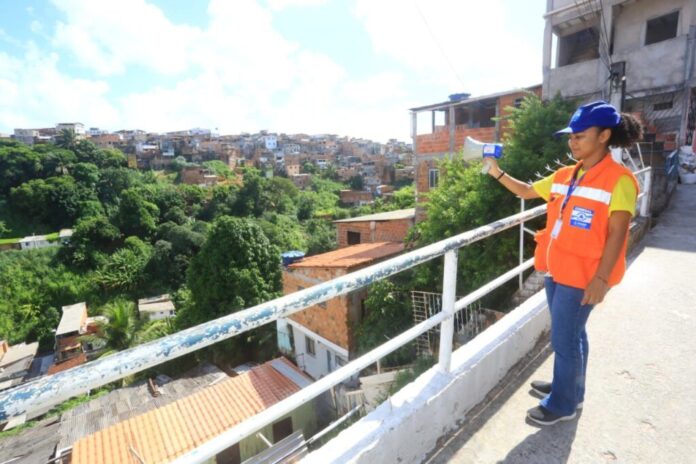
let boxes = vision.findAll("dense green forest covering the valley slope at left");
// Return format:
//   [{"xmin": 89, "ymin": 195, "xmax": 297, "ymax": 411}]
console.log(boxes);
[{"xmin": 0, "ymin": 131, "xmax": 413, "ymax": 359}]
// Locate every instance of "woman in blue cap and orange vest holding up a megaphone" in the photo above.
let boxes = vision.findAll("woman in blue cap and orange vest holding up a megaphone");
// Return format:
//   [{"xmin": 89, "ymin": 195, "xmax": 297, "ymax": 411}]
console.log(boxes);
[{"xmin": 486, "ymin": 101, "xmax": 642, "ymax": 425}]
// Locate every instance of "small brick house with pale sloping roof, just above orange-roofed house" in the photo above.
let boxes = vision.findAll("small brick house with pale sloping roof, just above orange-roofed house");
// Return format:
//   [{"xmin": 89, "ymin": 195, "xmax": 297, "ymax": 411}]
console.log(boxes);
[{"xmin": 334, "ymin": 208, "xmax": 416, "ymax": 248}]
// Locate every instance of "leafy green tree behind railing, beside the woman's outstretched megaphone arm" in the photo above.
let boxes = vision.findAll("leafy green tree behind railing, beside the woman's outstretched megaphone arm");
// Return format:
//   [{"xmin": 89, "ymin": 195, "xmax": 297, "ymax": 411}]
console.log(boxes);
[{"xmin": 414, "ymin": 96, "xmax": 574, "ymax": 299}]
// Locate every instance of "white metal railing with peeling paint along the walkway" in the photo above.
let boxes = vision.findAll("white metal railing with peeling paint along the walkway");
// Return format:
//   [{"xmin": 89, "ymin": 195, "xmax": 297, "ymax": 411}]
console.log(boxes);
[{"xmin": 0, "ymin": 168, "xmax": 650, "ymax": 463}]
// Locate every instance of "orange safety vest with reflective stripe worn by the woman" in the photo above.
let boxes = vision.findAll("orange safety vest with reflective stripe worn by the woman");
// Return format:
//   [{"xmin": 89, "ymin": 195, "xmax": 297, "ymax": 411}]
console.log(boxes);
[{"xmin": 534, "ymin": 154, "xmax": 638, "ymax": 289}]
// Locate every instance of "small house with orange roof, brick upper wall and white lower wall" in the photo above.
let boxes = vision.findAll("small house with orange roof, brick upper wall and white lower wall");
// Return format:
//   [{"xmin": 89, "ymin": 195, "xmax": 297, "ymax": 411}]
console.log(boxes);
[{"xmin": 277, "ymin": 242, "xmax": 404, "ymax": 379}]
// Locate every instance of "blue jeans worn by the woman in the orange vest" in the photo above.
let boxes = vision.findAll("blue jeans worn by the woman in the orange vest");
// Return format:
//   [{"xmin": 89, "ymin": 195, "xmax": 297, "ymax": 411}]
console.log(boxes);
[{"xmin": 541, "ymin": 277, "xmax": 594, "ymax": 416}]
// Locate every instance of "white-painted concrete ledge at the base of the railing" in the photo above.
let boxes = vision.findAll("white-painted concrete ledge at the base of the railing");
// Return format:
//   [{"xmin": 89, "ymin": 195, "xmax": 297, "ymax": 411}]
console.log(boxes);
[{"xmin": 301, "ymin": 291, "xmax": 550, "ymax": 464}]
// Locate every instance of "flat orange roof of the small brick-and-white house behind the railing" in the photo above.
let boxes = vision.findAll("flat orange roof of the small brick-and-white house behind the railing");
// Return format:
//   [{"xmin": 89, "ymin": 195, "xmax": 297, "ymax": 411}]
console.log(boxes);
[{"xmin": 289, "ymin": 242, "xmax": 404, "ymax": 269}]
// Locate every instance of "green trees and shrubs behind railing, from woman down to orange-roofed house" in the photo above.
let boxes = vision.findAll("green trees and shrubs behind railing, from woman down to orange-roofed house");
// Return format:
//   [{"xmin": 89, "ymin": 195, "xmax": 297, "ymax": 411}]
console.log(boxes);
[{"xmin": 358, "ymin": 95, "xmax": 574, "ymax": 365}]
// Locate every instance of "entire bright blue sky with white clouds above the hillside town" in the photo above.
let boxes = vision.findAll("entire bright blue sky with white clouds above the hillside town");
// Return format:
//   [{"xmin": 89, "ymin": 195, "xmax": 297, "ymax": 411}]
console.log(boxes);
[{"xmin": 0, "ymin": 0, "xmax": 545, "ymax": 141}]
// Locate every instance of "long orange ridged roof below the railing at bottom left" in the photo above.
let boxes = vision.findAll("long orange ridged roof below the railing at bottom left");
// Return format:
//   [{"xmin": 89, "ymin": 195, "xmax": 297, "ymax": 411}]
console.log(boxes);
[{"xmin": 71, "ymin": 358, "xmax": 308, "ymax": 464}]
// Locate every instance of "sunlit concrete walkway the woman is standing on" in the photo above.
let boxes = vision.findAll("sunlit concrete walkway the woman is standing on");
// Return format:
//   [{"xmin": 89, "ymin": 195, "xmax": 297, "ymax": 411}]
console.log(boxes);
[{"xmin": 427, "ymin": 185, "xmax": 696, "ymax": 464}]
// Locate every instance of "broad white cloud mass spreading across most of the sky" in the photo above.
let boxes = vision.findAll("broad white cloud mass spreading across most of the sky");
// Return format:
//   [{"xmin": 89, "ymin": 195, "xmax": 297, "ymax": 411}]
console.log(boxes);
[{"xmin": 5, "ymin": 0, "xmax": 540, "ymax": 140}]
